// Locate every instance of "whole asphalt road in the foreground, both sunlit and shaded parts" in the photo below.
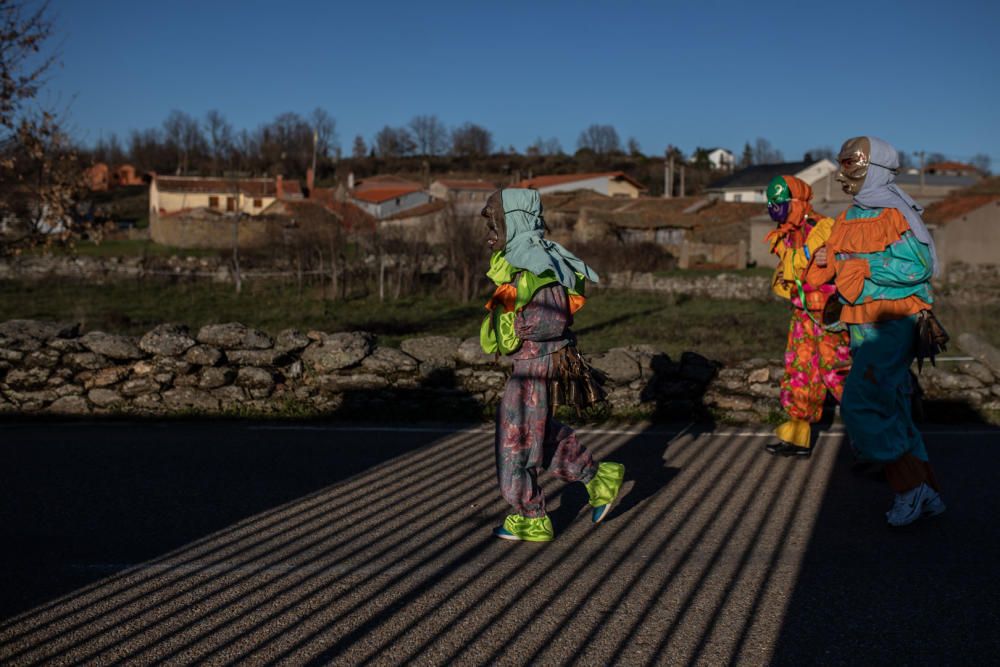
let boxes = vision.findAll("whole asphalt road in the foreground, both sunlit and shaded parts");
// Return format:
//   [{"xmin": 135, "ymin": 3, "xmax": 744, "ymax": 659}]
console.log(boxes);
[{"xmin": 0, "ymin": 421, "xmax": 1000, "ymax": 665}]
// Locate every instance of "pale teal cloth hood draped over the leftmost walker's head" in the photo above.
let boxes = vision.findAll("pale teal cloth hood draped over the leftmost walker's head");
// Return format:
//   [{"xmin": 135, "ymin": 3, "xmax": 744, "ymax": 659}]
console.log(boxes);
[{"xmin": 501, "ymin": 188, "xmax": 600, "ymax": 289}]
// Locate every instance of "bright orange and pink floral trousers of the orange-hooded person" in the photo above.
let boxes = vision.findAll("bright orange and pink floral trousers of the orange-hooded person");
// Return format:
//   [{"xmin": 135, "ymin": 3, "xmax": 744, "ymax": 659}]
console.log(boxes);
[{"xmin": 781, "ymin": 308, "xmax": 851, "ymax": 423}]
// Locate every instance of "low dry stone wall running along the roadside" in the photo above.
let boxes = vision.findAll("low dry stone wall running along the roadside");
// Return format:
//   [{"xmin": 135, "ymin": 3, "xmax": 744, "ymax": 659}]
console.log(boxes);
[{"xmin": 0, "ymin": 320, "xmax": 1000, "ymax": 422}]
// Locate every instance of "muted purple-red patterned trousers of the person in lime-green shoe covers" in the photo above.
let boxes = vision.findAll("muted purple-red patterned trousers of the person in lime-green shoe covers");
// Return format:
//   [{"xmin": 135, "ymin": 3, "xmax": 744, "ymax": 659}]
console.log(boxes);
[{"xmin": 496, "ymin": 355, "xmax": 597, "ymax": 518}]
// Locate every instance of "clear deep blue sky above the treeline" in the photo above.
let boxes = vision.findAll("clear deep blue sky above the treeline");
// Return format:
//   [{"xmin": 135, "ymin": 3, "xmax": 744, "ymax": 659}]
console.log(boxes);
[{"xmin": 46, "ymin": 0, "xmax": 1000, "ymax": 166}]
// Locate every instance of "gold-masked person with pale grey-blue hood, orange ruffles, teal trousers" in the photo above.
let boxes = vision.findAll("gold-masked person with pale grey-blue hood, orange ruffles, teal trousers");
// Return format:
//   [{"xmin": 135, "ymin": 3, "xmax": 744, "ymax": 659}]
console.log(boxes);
[{"xmin": 806, "ymin": 137, "xmax": 945, "ymax": 526}]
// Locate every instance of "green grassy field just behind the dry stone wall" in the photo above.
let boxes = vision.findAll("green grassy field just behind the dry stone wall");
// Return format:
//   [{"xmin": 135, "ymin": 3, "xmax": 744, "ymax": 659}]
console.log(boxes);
[{"xmin": 0, "ymin": 281, "xmax": 1000, "ymax": 362}]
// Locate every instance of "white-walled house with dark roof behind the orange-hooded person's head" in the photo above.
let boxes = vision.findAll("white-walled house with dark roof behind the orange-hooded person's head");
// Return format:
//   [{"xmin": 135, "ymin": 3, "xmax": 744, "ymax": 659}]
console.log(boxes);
[{"xmin": 705, "ymin": 158, "xmax": 840, "ymax": 204}]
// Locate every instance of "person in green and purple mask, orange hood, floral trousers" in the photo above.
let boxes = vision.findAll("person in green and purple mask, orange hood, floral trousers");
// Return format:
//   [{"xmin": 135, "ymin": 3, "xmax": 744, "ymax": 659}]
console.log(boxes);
[{"xmin": 765, "ymin": 176, "xmax": 851, "ymax": 456}]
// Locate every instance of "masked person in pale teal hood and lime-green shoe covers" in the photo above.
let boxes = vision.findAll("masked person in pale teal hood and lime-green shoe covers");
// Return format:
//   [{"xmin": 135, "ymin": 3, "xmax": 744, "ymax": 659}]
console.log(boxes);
[{"xmin": 480, "ymin": 189, "xmax": 625, "ymax": 542}]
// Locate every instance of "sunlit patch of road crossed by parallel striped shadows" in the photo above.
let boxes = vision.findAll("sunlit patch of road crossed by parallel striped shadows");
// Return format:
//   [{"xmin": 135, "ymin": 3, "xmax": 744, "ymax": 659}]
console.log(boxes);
[{"xmin": 0, "ymin": 428, "xmax": 840, "ymax": 665}]
